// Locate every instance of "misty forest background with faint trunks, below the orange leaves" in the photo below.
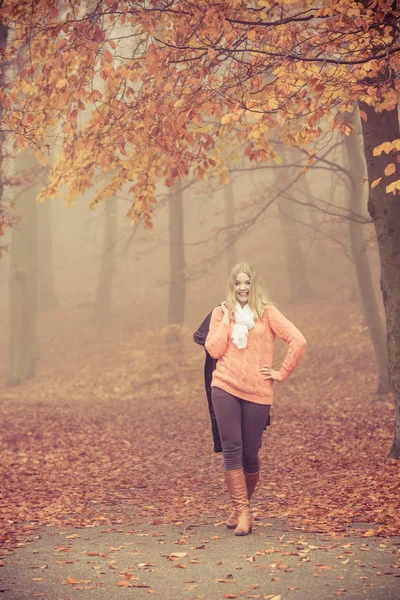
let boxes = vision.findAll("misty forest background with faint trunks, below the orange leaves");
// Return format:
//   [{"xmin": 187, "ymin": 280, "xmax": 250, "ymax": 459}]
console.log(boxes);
[{"xmin": 0, "ymin": 134, "xmax": 386, "ymax": 394}]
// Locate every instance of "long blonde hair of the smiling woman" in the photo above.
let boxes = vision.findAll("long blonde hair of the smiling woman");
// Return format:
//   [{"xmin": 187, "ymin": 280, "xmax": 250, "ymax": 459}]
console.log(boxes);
[{"xmin": 226, "ymin": 262, "xmax": 272, "ymax": 319}]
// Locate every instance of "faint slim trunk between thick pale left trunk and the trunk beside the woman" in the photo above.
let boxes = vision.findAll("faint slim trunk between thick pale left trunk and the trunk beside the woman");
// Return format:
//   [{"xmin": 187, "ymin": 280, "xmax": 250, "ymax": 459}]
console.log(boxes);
[{"xmin": 93, "ymin": 198, "xmax": 117, "ymax": 323}]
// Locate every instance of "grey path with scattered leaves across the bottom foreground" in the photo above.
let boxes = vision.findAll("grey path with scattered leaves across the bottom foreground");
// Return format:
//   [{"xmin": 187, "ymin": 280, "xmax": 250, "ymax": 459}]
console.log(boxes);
[{"xmin": 0, "ymin": 519, "xmax": 400, "ymax": 600}]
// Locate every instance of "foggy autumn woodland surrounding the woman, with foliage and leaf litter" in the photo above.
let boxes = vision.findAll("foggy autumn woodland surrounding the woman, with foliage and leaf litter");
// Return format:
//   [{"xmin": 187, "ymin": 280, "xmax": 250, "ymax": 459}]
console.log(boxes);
[{"xmin": 0, "ymin": 0, "xmax": 400, "ymax": 580}]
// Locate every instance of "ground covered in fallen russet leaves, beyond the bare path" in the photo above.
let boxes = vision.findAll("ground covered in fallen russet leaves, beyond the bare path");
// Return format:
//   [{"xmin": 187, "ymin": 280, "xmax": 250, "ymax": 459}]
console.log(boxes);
[{"xmin": 0, "ymin": 305, "xmax": 400, "ymax": 549}]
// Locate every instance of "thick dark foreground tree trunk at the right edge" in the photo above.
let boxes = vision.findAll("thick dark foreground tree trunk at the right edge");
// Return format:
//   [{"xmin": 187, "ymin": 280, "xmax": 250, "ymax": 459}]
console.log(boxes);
[{"xmin": 360, "ymin": 102, "xmax": 400, "ymax": 458}]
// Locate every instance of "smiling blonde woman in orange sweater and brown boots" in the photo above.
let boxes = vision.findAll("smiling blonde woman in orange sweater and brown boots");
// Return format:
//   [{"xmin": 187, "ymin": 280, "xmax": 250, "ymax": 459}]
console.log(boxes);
[{"xmin": 205, "ymin": 262, "xmax": 306, "ymax": 535}]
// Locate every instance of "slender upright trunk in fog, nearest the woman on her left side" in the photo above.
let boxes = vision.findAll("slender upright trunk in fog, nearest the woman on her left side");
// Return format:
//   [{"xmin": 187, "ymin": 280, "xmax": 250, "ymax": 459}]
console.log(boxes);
[{"xmin": 167, "ymin": 181, "xmax": 185, "ymax": 342}]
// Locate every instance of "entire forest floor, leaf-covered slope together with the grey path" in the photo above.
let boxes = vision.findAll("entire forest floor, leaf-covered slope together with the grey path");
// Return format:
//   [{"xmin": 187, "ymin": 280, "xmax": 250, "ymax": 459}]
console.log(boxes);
[{"xmin": 0, "ymin": 304, "xmax": 400, "ymax": 600}]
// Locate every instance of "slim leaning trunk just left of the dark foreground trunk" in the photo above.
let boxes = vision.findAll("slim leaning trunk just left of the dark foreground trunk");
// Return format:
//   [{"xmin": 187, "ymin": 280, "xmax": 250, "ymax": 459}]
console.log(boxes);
[{"xmin": 344, "ymin": 120, "xmax": 391, "ymax": 394}]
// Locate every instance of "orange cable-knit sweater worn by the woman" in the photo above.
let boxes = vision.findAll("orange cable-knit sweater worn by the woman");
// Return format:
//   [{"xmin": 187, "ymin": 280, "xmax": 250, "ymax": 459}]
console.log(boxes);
[{"xmin": 205, "ymin": 304, "xmax": 306, "ymax": 404}]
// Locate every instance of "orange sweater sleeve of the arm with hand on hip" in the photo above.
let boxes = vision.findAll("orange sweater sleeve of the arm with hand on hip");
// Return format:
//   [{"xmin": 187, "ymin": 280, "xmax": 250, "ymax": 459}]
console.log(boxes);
[{"xmin": 267, "ymin": 305, "xmax": 307, "ymax": 381}]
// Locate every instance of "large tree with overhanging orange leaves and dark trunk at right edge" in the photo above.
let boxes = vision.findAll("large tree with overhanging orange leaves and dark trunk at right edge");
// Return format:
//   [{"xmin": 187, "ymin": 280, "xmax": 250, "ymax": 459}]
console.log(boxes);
[{"xmin": 0, "ymin": 0, "xmax": 400, "ymax": 456}]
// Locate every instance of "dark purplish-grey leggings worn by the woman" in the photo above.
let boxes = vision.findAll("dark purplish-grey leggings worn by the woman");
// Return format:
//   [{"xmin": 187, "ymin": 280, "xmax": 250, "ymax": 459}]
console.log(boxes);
[{"xmin": 211, "ymin": 387, "xmax": 271, "ymax": 473}]
